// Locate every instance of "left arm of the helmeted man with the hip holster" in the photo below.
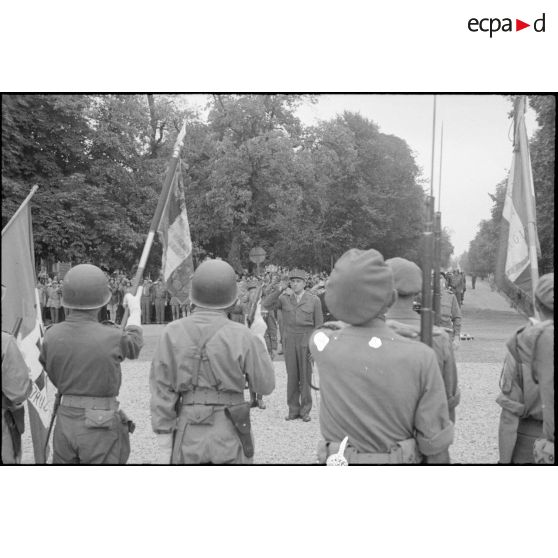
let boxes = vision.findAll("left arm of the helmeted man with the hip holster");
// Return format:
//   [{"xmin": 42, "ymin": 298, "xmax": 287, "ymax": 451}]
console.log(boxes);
[{"xmin": 149, "ymin": 331, "xmax": 180, "ymax": 434}]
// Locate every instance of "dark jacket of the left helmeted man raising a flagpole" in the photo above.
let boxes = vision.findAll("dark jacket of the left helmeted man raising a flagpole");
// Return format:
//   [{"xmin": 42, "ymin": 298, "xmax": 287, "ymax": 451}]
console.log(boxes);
[{"xmin": 39, "ymin": 310, "xmax": 143, "ymax": 397}]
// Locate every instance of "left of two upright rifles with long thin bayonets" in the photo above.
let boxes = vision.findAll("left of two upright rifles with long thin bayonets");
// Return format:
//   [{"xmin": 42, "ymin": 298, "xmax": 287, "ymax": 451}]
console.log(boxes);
[{"xmin": 420, "ymin": 95, "xmax": 436, "ymax": 346}]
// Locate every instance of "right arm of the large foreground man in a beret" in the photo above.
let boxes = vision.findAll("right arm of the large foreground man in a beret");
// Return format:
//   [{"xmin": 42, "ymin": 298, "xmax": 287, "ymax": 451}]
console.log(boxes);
[{"xmin": 415, "ymin": 350, "xmax": 453, "ymax": 463}]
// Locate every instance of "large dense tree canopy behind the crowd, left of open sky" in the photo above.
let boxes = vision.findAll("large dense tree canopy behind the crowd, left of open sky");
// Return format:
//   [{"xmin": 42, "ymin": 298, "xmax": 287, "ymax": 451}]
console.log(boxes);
[{"xmin": 2, "ymin": 94, "xmax": 446, "ymax": 271}]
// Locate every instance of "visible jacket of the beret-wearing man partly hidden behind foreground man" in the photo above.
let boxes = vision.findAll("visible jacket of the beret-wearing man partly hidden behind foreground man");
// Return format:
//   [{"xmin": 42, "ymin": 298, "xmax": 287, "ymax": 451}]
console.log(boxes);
[{"xmin": 387, "ymin": 309, "xmax": 461, "ymax": 423}]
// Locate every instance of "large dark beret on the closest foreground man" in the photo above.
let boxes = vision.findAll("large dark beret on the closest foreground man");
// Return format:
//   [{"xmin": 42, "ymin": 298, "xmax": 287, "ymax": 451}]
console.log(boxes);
[{"xmin": 325, "ymin": 248, "xmax": 394, "ymax": 325}]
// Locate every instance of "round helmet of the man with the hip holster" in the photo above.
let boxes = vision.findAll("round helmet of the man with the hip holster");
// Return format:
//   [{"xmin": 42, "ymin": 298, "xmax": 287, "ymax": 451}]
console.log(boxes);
[{"xmin": 190, "ymin": 259, "xmax": 237, "ymax": 310}]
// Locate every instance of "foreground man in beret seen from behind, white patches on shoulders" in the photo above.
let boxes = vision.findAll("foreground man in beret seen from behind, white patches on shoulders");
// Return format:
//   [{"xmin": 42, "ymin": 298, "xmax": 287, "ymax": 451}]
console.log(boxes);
[{"xmin": 310, "ymin": 249, "xmax": 453, "ymax": 464}]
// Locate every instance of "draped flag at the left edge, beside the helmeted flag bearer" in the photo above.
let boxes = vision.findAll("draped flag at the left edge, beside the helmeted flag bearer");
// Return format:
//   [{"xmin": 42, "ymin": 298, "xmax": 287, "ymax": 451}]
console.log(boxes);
[{"xmin": 2, "ymin": 198, "xmax": 51, "ymax": 463}]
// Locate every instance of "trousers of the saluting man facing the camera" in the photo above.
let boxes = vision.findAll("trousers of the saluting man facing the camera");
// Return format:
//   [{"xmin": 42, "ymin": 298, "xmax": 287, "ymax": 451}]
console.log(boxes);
[{"xmin": 283, "ymin": 331, "xmax": 312, "ymax": 417}]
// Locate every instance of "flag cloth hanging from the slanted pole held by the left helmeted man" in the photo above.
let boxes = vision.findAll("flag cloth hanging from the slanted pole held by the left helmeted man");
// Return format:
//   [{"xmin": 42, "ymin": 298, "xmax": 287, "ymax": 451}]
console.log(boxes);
[{"xmin": 158, "ymin": 161, "xmax": 194, "ymax": 304}]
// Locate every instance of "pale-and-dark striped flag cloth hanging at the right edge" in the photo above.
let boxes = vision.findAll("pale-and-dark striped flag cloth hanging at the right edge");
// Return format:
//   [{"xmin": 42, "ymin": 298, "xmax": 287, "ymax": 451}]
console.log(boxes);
[{"xmin": 502, "ymin": 97, "xmax": 540, "ymax": 293}]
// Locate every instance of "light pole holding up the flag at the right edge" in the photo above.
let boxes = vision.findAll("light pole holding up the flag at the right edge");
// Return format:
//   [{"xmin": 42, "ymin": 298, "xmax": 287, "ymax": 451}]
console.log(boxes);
[{"xmin": 517, "ymin": 95, "xmax": 539, "ymax": 312}]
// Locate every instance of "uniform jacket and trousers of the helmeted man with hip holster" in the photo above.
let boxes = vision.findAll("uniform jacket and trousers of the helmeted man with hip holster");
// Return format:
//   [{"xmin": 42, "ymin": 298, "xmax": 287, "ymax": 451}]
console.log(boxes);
[{"xmin": 149, "ymin": 308, "xmax": 275, "ymax": 464}]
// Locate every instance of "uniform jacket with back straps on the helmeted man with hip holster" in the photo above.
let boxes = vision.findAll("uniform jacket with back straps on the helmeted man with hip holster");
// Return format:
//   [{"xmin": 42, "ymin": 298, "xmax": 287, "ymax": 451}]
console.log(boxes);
[{"xmin": 149, "ymin": 308, "xmax": 275, "ymax": 434}]
